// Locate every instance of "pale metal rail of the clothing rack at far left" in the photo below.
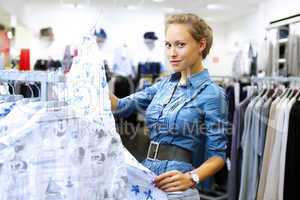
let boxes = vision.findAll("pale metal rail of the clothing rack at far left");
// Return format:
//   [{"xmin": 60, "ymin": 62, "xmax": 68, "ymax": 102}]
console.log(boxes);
[{"xmin": 0, "ymin": 70, "xmax": 65, "ymax": 101}]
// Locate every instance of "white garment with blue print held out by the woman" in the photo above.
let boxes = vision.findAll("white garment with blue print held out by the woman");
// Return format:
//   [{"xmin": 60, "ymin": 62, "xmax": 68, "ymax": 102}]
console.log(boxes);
[{"xmin": 67, "ymin": 35, "xmax": 166, "ymax": 200}]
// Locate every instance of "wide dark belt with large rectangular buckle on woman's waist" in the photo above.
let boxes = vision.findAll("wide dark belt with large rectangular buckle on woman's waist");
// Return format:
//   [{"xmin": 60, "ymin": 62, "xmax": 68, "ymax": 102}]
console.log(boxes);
[{"xmin": 147, "ymin": 141, "xmax": 192, "ymax": 163}]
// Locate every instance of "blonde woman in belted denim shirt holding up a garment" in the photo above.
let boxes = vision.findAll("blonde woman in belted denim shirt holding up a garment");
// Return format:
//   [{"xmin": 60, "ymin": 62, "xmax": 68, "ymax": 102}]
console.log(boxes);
[{"xmin": 111, "ymin": 14, "xmax": 227, "ymax": 200}]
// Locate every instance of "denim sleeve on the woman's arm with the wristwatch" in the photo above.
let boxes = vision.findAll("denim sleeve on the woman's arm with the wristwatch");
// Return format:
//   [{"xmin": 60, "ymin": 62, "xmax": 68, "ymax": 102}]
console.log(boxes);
[{"xmin": 204, "ymin": 87, "xmax": 228, "ymax": 161}]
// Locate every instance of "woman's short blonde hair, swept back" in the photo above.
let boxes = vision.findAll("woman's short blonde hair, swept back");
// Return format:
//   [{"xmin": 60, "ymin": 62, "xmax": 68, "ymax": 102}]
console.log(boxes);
[{"xmin": 165, "ymin": 13, "xmax": 213, "ymax": 59}]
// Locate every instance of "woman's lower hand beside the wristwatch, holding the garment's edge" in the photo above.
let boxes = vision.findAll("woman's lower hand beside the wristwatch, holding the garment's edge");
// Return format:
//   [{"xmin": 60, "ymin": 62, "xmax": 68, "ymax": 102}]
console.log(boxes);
[{"xmin": 154, "ymin": 170, "xmax": 194, "ymax": 192}]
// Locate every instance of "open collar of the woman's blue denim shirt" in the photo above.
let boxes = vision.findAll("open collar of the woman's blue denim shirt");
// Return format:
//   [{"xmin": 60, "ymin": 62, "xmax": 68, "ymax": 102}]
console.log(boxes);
[{"xmin": 170, "ymin": 69, "xmax": 210, "ymax": 89}]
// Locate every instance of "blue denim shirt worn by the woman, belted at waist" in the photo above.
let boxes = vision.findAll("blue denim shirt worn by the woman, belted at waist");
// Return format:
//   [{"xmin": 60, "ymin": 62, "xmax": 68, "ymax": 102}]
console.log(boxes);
[{"xmin": 117, "ymin": 69, "xmax": 228, "ymax": 174}]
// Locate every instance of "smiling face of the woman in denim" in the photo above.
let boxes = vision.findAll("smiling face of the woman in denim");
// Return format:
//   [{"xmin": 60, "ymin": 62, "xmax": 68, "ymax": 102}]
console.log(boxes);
[{"xmin": 165, "ymin": 24, "xmax": 205, "ymax": 72}]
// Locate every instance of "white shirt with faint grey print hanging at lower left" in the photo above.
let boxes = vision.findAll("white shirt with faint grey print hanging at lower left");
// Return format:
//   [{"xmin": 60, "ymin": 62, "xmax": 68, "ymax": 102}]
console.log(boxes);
[{"xmin": 0, "ymin": 108, "xmax": 126, "ymax": 200}]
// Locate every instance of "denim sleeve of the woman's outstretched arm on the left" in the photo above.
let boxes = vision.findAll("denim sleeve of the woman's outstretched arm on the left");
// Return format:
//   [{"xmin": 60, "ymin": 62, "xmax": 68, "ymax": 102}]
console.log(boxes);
[{"xmin": 114, "ymin": 80, "xmax": 163, "ymax": 117}]
